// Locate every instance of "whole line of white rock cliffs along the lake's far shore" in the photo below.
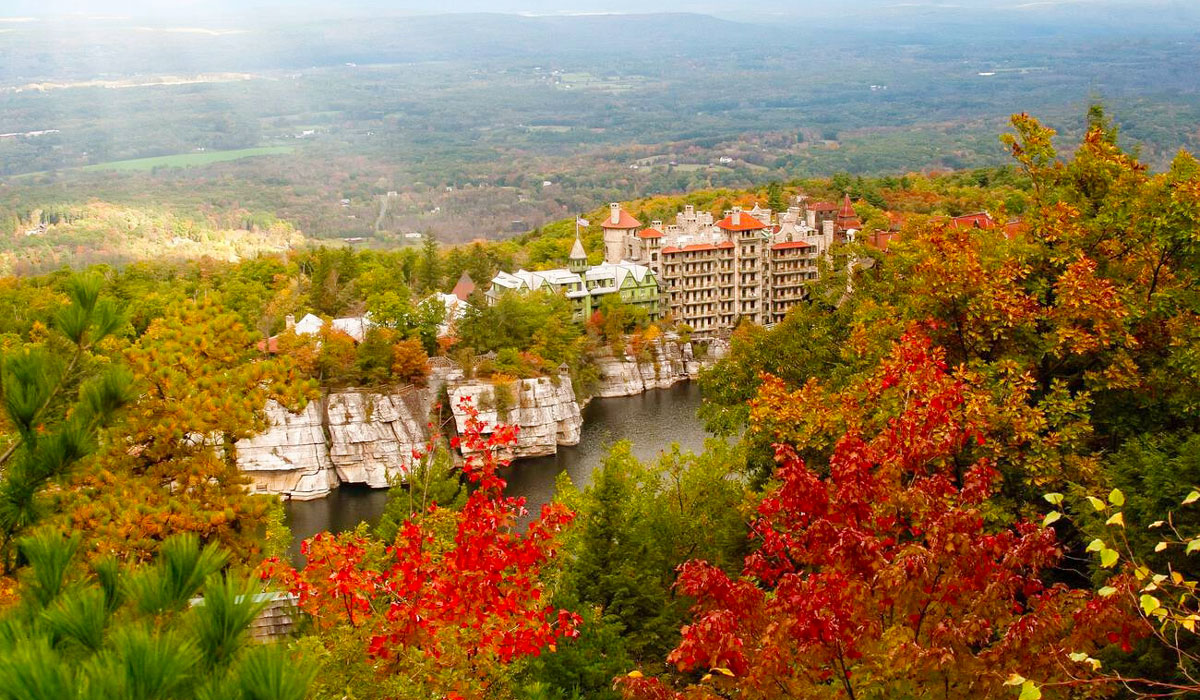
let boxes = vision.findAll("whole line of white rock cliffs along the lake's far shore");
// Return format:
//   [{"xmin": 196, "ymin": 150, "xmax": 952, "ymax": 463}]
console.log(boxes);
[{"xmin": 236, "ymin": 336, "xmax": 727, "ymax": 501}]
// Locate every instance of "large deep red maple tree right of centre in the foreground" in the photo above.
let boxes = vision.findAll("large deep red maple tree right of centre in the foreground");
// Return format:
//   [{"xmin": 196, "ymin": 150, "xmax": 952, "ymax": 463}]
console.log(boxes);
[{"xmin": 619, "ymin": 330, "xmax": 1132, "ymax": 699}]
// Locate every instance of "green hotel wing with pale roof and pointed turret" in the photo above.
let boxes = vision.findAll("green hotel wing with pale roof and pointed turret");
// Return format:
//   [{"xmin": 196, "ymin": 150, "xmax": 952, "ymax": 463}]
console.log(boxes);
[{"xmin": 486, "ymin": 236, "xmax": 661, "ymax": 319}]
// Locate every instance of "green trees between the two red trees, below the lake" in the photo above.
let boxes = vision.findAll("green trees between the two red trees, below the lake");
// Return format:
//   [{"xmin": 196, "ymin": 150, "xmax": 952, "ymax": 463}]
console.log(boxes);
[{"xmin": 538, "ymin": 441, "xmax": 749, "ymax": 695}]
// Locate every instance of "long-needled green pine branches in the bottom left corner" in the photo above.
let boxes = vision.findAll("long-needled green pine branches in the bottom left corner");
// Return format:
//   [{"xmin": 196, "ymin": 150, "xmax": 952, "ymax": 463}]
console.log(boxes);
[{"xmin": 0, "ymin": 532, "xmax": 313, "ymax": 700}]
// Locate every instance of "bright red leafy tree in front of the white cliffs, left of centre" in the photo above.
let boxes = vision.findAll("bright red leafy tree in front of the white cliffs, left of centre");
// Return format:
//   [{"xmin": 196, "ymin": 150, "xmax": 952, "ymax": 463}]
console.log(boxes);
[{"xmin": 269, "ymin": 396, "xmax": 580, "ymax": 681}]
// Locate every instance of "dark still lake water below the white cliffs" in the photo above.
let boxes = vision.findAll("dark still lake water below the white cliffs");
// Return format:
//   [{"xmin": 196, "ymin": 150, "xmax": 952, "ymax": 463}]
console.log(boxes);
[{"xmin": 284, "ymin": 382, "xmax": 709, "ymax": 558}]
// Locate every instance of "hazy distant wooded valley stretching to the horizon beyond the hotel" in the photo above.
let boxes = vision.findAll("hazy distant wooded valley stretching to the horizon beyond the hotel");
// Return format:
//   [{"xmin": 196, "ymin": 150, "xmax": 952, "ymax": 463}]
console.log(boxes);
[{"xmin": 0, "ymin": 13, "xmax": 1200, "ymax": 249}]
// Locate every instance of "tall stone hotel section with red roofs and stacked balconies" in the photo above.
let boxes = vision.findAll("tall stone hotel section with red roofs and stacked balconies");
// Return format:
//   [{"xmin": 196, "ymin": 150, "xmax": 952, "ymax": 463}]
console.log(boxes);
[{"xmin": 609, "ymin": 197, "xmax": 862, "ymax": 335}]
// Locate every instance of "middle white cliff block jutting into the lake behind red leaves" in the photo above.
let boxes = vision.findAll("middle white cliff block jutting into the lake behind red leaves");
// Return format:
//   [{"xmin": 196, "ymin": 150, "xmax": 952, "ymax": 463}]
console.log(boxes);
[{"xmin": 448, "ymin": 376, "xmax": 583, "ymax": 459}]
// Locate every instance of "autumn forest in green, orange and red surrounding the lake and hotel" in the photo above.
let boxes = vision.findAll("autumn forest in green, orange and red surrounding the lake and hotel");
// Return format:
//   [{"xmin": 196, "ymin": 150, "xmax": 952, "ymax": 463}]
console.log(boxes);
[{"xmin": 0, "ymin": 108, "xmax": 1200, "ymax": 700}]
